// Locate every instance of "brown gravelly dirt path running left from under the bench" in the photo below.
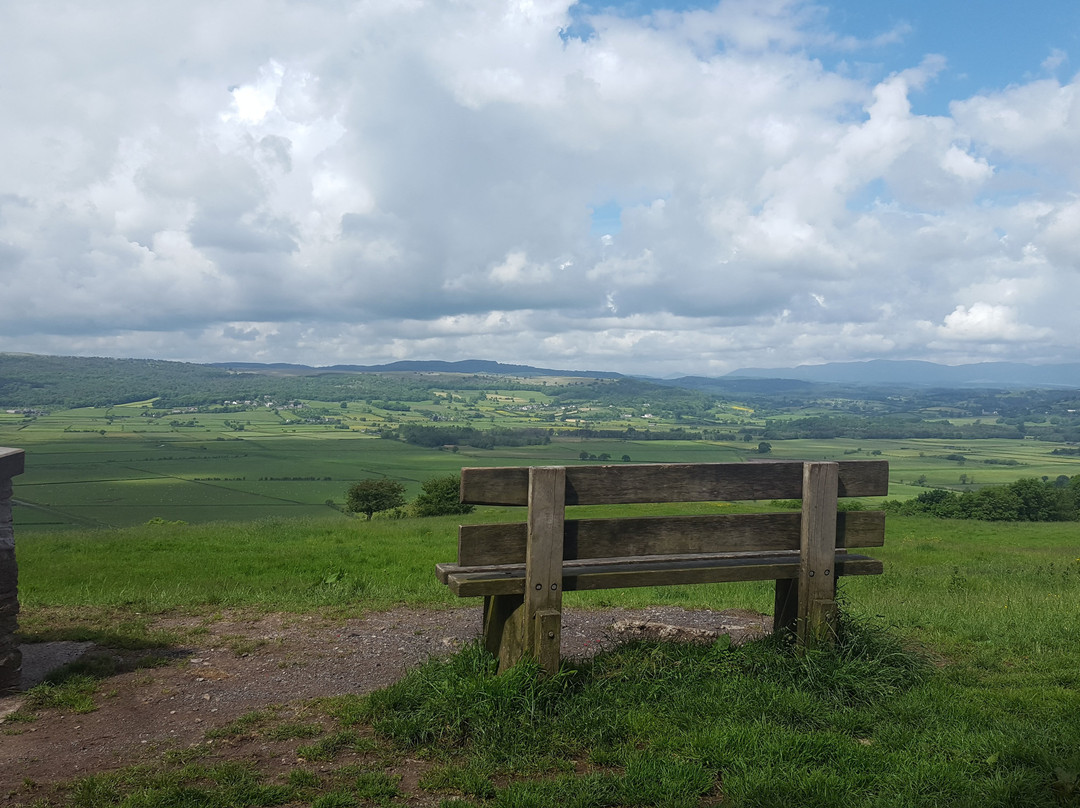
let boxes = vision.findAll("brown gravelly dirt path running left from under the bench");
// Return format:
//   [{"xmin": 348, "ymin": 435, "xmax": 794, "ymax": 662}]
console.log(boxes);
[{"xmin": 0, "ymin": 606, "xmax": 768, "ymax": 805}]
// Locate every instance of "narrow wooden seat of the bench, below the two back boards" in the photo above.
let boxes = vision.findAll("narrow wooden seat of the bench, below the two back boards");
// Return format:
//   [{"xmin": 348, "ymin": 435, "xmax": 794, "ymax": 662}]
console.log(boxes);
[{"xmin": 438, "ymin": 553, "xmax": 882, "ymax": 597}]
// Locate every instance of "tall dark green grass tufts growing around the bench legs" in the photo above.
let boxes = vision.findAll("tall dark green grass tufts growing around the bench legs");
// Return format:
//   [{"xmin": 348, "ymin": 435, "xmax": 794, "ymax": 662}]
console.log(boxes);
[{"xmin": 352, "ymin": 618, "xmax": 930, "ymax": 768}]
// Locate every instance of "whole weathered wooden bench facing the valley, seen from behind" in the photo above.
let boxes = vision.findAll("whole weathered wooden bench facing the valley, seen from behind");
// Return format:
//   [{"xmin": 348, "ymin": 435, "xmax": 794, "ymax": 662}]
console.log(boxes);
[{"xmin": 436, "ymin": 460, "xmax": 889, "ymax": 672}]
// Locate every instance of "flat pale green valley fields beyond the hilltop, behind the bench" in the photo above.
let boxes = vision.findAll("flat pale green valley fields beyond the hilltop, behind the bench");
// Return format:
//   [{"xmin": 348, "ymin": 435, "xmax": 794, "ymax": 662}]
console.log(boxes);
[{"xmin": 6, "ymin": 404, "xmax": 1080, "ymax": 533}]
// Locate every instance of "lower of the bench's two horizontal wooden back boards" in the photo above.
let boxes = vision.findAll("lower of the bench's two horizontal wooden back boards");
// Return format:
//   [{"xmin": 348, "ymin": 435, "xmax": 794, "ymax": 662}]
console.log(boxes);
[{"xmin": 458, "ymin": 511, "xmax": 885, "ymax": 567}]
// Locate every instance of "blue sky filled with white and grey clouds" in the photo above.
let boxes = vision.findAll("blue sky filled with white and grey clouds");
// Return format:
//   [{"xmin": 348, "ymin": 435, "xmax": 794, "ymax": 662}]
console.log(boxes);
[{"xmin": 0, "ymin": 0, "xmax": 1080, "ymax": 375}]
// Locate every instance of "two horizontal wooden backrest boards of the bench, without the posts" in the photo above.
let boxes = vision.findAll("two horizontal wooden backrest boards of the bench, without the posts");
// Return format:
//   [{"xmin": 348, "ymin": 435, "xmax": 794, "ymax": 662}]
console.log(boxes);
[{"xmin": 458, "ymin": 460, "xmax": 889, "ymax": 566}]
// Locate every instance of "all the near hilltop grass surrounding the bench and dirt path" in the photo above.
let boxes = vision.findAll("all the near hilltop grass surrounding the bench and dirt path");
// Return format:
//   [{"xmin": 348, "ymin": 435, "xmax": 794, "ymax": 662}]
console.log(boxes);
[{"xmin": 17, "ymin": 509, "xmax": 1080, "ymax": 808}]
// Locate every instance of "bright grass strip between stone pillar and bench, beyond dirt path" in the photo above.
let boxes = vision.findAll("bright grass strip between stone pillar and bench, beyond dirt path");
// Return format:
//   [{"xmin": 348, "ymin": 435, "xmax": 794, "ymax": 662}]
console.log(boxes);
[{"xmin": 16, "ymin": 517, "xmax": 457, "ymax": 614}]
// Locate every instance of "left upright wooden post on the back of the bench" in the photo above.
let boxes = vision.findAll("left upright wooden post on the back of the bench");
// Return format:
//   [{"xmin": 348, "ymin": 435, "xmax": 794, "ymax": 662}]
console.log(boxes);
[{"xmin": 524, "ymin": 467, "xmax": 566, "ymax": 673}]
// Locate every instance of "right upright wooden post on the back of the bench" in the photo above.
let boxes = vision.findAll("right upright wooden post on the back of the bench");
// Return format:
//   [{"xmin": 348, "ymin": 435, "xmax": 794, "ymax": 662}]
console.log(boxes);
[{"xmin": 797, "ymin": 462, "xmax": 839, "ymax": 646}]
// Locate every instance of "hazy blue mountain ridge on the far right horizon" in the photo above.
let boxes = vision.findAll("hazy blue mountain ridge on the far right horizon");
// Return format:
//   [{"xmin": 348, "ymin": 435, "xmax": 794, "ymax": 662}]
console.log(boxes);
[{"xmin": 721, "ymin": 359, "xmax": 1080, "ymax": 388}]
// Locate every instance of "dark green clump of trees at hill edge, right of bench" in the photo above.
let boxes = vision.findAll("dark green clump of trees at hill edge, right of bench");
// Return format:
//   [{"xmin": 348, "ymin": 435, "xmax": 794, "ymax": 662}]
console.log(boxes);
[{"xmin": 885, "ymin": 474, "xmax": 1080, "ymax": 522}]
